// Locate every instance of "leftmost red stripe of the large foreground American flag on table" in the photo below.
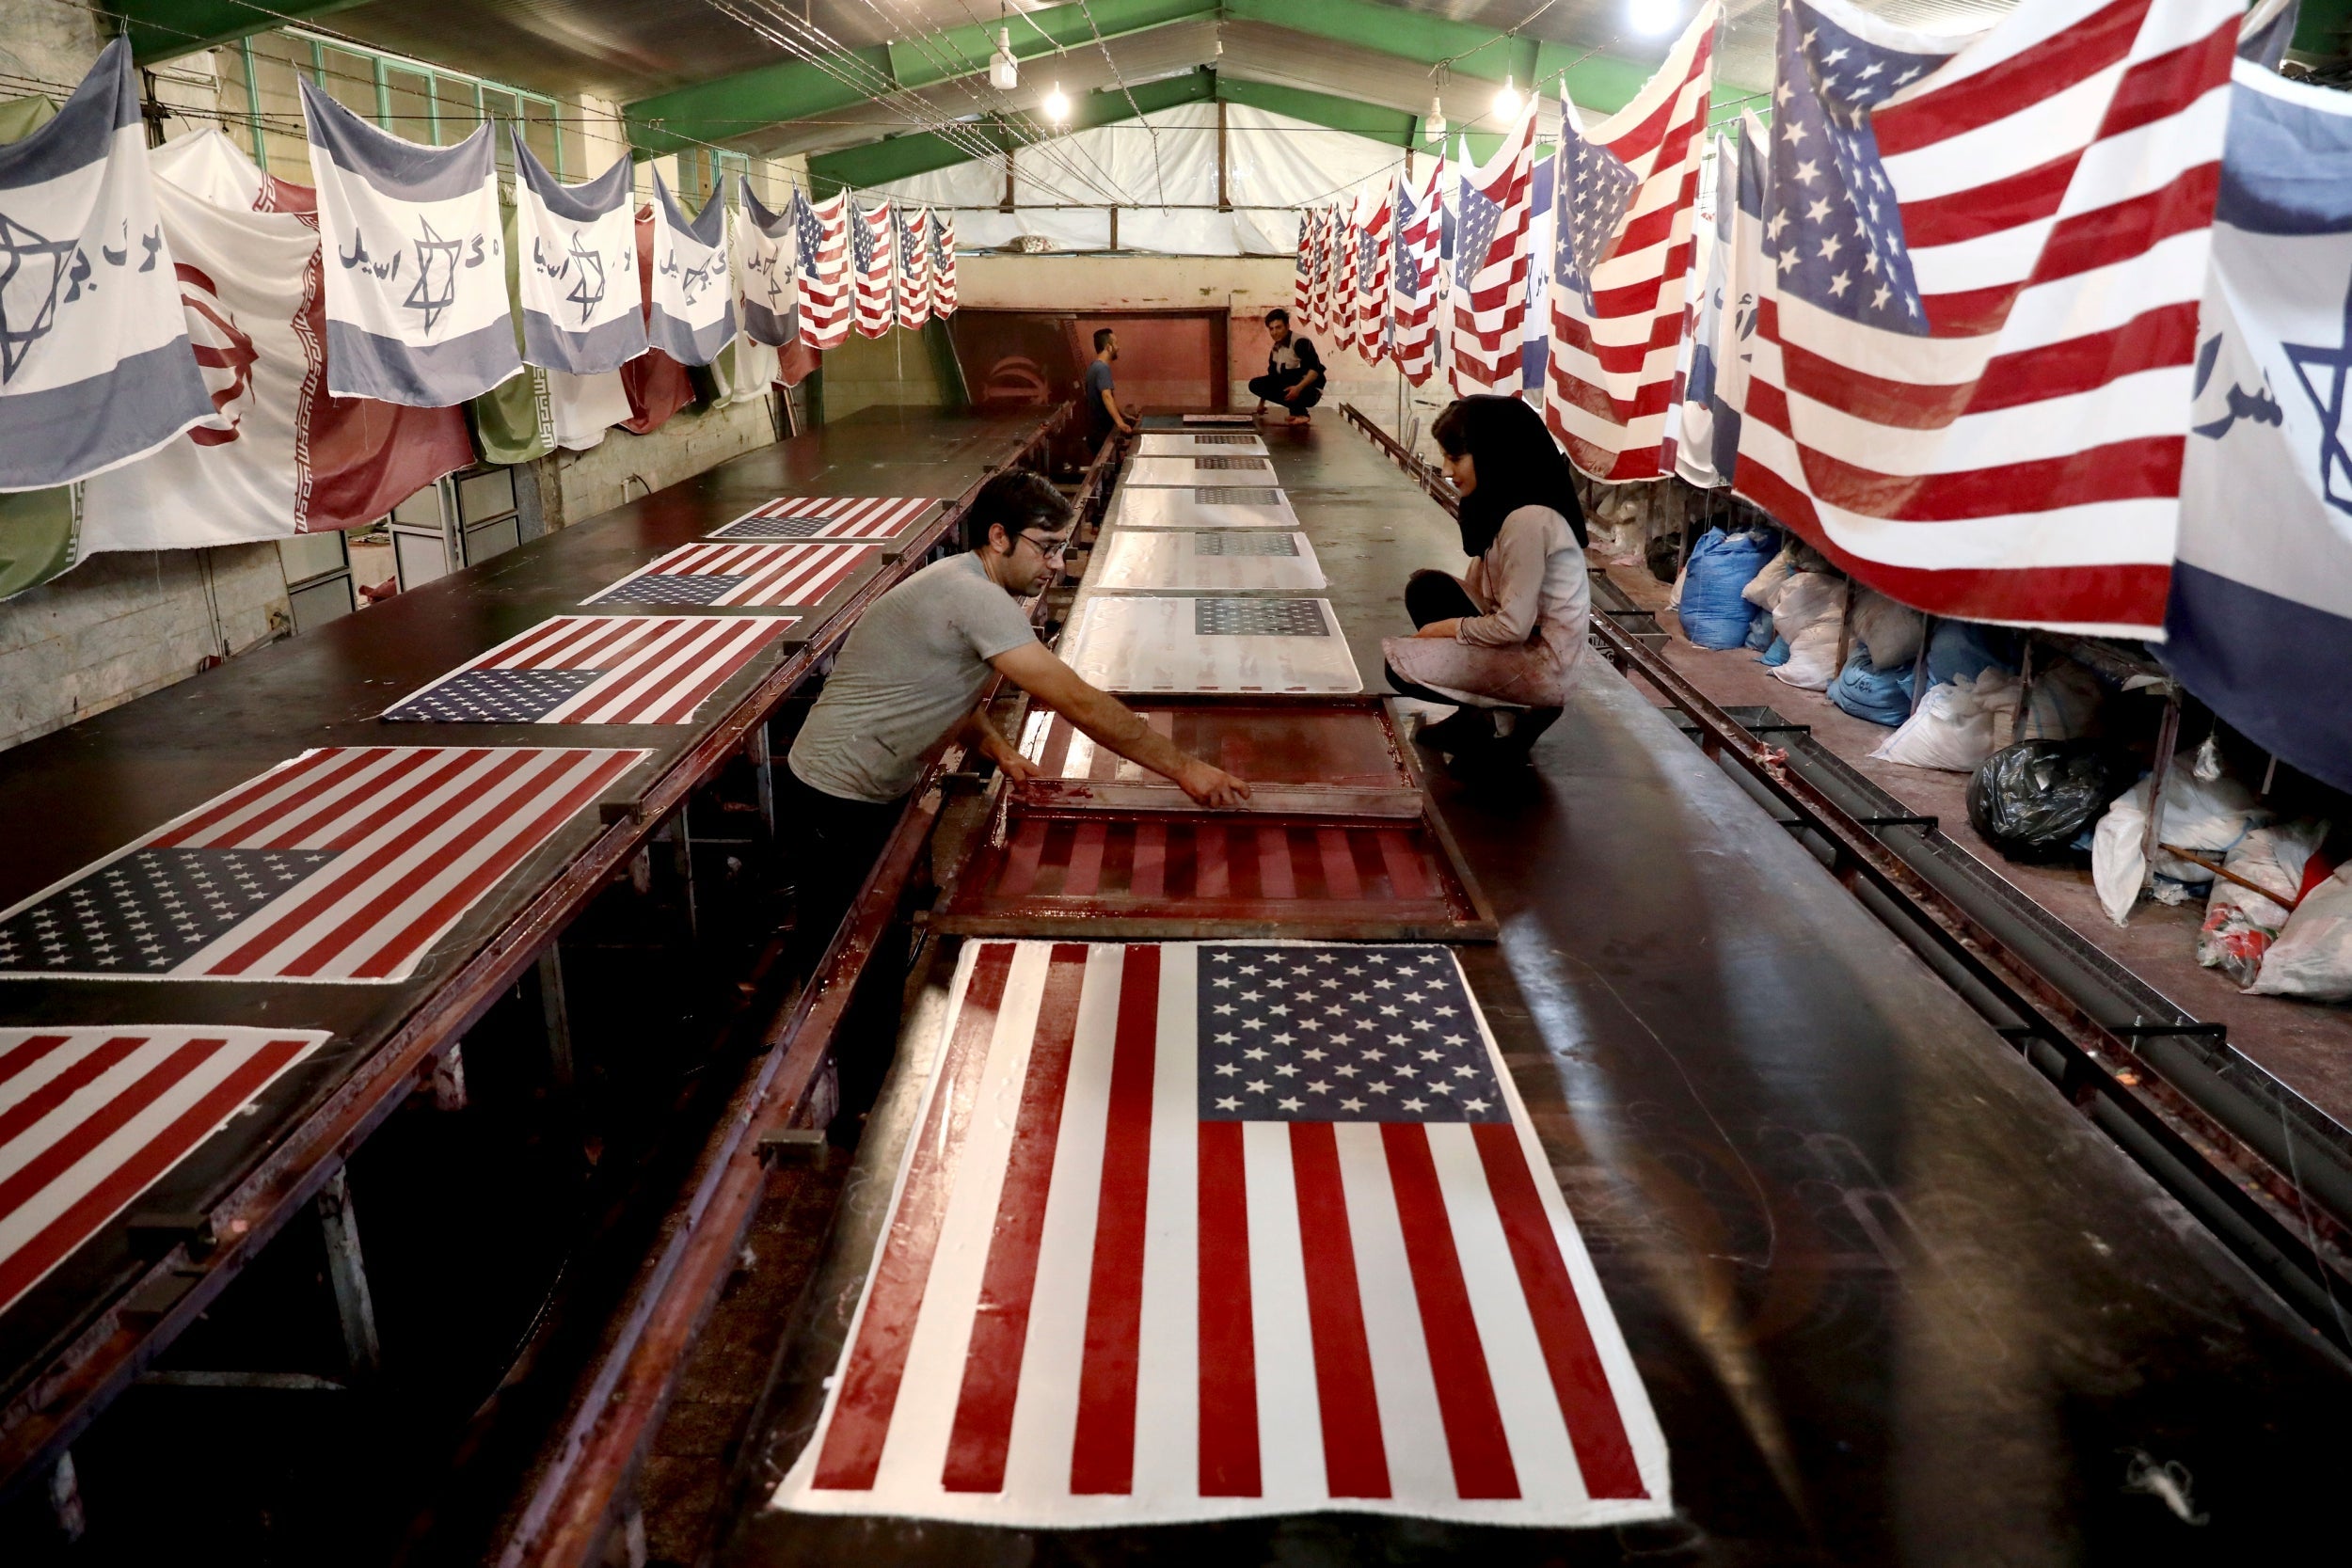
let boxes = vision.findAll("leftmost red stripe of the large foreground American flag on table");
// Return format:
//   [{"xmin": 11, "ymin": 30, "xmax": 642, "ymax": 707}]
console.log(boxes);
[{"xmin": 817, "ymin": 942, "xmax": 1014, "ymax": 1491}]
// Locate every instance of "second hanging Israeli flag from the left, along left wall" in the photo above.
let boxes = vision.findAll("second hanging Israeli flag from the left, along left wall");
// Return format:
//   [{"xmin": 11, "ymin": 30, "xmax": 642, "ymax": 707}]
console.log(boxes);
[{"xmin": 301, "ymin": 77, "xmax": 522, "ymax": 409}]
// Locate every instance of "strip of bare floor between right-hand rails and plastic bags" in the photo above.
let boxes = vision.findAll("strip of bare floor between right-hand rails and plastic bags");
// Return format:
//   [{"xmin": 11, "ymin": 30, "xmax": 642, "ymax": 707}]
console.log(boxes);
[{"xmin": 1609, "ymin": 566, "xmax": 2352, "ymax": 1126}]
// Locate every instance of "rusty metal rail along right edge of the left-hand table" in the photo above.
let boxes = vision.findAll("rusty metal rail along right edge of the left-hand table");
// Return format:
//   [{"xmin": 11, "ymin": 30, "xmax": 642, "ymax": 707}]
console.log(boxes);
[{"xmin": 0, "ymin": 404, "xmax": 1071, "ymax": 1497}]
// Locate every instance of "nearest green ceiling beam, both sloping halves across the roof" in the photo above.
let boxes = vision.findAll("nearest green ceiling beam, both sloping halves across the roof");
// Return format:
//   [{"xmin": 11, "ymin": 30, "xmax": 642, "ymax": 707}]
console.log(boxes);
[{"xmin": 624, "ymin": 0, "xmax": 1750, "ymax": 157}]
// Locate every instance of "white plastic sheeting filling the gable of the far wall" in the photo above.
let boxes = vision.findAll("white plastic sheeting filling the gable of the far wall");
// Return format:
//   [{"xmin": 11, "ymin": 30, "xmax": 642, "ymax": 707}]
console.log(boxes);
[{"xmin": 880, "ymin": 103, "xmax": 1405, "ymax": 256}]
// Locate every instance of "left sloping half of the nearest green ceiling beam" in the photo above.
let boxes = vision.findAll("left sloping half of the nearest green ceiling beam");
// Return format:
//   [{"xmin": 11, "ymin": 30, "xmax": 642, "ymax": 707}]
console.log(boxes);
[{"xmin": 621, "ymin": 0, "xmax": 1218, "ymax": 157}]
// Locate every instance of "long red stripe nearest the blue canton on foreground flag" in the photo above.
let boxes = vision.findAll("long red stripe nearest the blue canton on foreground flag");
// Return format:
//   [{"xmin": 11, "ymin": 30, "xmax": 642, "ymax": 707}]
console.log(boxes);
[{"xmin": 1071, "ymin": 947, "xmax": 1160, "ymax": 1493}]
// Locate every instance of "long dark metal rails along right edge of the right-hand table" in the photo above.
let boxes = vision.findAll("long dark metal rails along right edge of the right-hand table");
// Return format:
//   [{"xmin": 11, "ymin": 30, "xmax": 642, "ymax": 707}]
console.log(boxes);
[{"xmin": 1341, "ymin": 404, "xmax": 2352, "ymax": 1352}]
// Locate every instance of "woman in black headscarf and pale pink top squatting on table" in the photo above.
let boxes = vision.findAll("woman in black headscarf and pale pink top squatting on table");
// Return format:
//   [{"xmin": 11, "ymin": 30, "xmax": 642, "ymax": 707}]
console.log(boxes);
[{"xmin": 1381, "ymin": 397, "xmax": 1593, "ymax": 759}]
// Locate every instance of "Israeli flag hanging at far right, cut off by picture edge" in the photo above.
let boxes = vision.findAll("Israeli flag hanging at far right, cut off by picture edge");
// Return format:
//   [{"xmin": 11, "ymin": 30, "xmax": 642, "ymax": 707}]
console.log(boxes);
[{"xmin": 2162, "ymin": 58, "xmax": 2352, "ymax": 790}]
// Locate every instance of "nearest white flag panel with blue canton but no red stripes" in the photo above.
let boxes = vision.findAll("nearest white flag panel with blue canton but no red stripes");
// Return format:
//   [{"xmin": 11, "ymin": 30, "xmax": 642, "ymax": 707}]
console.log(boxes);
[{"xmin": 1063, "ymin": 593, "xmax": 1364, "ymax": 693}]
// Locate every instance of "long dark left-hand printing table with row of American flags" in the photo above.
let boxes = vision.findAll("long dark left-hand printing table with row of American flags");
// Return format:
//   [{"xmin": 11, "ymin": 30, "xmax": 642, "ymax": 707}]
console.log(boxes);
[{"xmin": 0, "ymin": 409, "xmax": 1063, "ymax": 1486}]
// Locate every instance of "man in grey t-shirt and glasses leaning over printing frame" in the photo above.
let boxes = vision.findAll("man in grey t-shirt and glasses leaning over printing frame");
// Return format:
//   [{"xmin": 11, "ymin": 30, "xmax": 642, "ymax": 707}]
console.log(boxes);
[{"xmin": 779, "ymin": 460, "xmax": 1249, "ymax": 942}]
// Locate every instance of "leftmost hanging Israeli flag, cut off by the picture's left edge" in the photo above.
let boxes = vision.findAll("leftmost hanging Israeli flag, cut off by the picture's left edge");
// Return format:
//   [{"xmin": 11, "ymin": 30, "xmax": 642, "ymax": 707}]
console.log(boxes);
[{"xmin": 0, "ymin": 38, "xmax": 212, "ymax": 491}]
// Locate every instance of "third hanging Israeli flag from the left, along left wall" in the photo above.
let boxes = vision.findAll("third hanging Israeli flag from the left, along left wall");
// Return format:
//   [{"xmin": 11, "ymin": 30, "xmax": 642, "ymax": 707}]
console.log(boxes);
[{"xmin": 508, "ymin": 129, "xmax": 644, "ymax": 376}]
